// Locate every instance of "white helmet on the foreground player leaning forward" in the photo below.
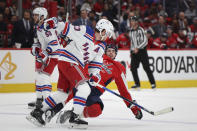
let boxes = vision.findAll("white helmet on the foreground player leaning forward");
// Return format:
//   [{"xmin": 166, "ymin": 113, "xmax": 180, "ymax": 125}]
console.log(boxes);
[{"xmin": 96, "ymin": 19, "xmax": 114, "ymax": 38}]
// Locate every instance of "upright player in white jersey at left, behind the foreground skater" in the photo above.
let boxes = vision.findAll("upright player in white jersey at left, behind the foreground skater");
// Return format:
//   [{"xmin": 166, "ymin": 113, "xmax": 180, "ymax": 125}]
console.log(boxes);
[{"xmin": 28, "ymin": 7, "xmax": 64, "ymax": 107}]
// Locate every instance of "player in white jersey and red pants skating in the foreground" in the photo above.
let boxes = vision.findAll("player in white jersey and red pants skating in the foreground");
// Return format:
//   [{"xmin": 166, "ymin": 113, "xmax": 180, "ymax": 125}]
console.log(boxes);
[{"xmin": 28, "ymin": 19, "xmax": 114, "ymax": 128}]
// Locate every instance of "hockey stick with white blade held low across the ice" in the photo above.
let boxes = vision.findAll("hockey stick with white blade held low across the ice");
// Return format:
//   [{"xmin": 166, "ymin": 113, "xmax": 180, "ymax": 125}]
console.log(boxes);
[{"xmin": 97, "ymin": 84, "xmax": 174, "ymax": 116}]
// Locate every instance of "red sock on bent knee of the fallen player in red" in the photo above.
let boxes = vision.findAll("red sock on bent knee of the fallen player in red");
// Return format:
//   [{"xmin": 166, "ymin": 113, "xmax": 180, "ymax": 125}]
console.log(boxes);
[{"xmin": 83, "ymin": 103, "xmax": 102, "ymax": 118}]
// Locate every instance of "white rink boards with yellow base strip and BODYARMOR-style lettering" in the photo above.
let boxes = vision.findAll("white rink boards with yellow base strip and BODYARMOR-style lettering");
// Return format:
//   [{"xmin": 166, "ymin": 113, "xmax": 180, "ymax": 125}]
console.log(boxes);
[{"xmin": 0, "ymin": 50, "xmax": 197, "ymax": 92}]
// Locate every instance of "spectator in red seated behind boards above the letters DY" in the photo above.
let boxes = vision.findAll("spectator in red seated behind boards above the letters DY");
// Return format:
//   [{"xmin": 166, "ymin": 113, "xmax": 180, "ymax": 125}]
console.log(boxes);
[{"xmin": 167, "ymin": 26, "xmax": 178, "ymax": 49}]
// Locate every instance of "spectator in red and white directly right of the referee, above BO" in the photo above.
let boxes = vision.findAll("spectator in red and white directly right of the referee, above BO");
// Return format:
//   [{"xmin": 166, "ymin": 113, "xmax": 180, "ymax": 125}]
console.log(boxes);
[{"xmin": 153, "ymin": 32, "xmax": 168, "ymax": 49}]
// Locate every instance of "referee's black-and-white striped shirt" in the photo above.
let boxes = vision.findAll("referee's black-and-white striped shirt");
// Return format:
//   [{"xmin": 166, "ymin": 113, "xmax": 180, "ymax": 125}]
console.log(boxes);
[{"xmin": 129, "ymin": 26, "xmax": 148, "ymax": 51}]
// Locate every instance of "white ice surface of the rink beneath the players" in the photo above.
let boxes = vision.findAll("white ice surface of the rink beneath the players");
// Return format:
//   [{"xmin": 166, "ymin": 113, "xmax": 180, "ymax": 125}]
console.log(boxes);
[{"xmin": 0, "ymin": 88, "xmax": 197, "ymax": 131}]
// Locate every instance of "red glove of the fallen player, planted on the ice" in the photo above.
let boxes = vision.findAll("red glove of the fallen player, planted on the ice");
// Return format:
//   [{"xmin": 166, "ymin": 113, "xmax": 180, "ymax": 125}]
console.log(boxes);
[{"xmin": 129, "ymin": 100, "xmax": 143, "ymax": 120}]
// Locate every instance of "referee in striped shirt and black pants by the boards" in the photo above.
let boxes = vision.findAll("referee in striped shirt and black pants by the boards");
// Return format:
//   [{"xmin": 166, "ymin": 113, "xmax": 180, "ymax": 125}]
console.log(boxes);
[{"xmin": 129, "ymin": 16, "xmax": 156, "ymax": 89}]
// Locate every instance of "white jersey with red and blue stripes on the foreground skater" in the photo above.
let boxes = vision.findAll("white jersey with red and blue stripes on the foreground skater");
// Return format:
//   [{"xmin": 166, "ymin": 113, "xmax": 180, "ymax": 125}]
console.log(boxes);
[{"xmin": 59, "ymin": 22, "xmax": 106, "ymax": 75}]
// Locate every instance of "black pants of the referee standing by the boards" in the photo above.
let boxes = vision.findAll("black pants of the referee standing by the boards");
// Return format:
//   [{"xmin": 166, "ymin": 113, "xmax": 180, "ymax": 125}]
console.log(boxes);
[{"xmin": 131, "ymin": 48, "xmax": 155, "ymax": 86}]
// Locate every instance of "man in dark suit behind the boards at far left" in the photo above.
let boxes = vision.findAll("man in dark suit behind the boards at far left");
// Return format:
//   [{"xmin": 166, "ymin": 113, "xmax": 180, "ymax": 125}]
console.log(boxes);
[{"xmin": 11, "ymin": 10, "xmax": 34, "ymax": 48}]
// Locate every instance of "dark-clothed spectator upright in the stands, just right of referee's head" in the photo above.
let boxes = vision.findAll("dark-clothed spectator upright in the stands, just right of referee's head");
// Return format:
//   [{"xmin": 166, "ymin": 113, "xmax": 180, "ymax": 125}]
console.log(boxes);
[{"xmin": 152, "ymin": 16, "xmax": 167, "ymax": 38}]
